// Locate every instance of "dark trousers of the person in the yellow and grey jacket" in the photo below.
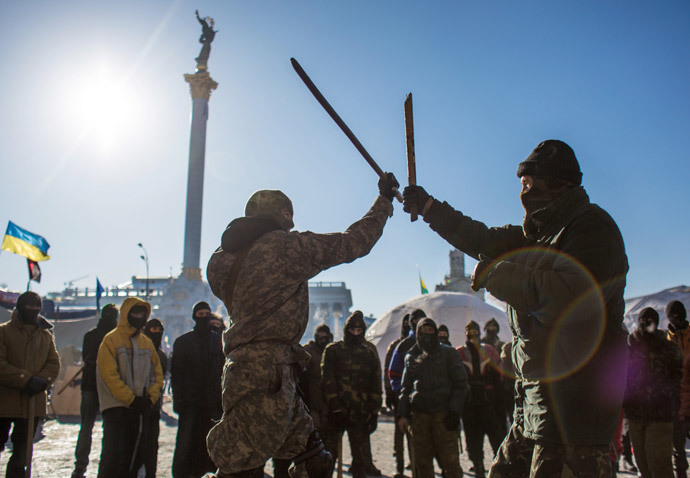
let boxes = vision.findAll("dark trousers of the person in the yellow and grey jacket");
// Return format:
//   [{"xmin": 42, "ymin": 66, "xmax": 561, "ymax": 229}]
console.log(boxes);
[{"xmin": 98, "ymin": 407, "xmax": 148, "ymax": 478}]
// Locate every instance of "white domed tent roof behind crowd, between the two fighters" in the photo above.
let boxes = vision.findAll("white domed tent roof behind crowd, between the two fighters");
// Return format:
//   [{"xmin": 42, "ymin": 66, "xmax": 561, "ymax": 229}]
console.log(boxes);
[{"xmin": 366, "ymin": 292, "xmax": 511, "ymax": 360}]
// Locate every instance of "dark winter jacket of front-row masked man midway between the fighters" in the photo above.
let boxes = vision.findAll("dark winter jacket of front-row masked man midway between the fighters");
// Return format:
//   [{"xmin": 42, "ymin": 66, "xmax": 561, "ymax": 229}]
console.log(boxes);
[{"xmin": 398, "ymin": 344, "xmax": 467, "ymax": 418}]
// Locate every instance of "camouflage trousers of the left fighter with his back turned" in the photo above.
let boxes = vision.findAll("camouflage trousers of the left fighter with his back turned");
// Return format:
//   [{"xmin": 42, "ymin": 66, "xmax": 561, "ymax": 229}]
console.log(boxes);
[{"xmin": 206, "ymin": 361, "xmax": 314, "ymax": 475}]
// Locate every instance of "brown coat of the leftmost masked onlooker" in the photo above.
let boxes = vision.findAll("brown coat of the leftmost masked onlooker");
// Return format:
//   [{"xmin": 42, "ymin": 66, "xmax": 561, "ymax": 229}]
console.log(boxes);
[{"xmin": 0, "ymin": 309, "xmax": 60, "ymax": 418}]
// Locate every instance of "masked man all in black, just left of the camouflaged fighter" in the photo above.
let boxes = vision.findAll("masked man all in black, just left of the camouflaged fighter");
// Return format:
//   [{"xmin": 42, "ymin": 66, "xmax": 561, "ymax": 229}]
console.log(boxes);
[{"xmin": 170, "ymin": 301, "xmax": 225, "ymax": 478}]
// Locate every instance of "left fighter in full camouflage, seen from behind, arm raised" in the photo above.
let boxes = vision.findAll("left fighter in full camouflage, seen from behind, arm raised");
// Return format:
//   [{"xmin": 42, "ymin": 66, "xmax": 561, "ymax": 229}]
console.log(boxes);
[{"xmin": 206, "ymin": 173, "xmax": 399, "ymax": 478}]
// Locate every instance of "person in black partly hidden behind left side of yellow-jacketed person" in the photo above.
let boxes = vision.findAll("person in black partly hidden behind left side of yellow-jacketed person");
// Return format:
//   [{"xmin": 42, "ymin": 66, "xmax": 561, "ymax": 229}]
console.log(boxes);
[{"xmin": 72, "ymin": 304, "xmax": 120, "ymax": 478}]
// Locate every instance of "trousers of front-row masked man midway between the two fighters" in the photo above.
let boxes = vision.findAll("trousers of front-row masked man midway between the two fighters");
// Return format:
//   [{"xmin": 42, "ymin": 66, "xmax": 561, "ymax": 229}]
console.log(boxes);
[{"xmin": 410, "ymin": 412, "xmax": 462, "ymax": 478}]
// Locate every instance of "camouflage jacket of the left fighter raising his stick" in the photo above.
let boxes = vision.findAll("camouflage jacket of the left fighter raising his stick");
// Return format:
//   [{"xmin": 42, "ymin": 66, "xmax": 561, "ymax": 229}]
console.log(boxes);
[{"xmin": 206, "ymin": 196, "xmax": 393, "ymax": 365}]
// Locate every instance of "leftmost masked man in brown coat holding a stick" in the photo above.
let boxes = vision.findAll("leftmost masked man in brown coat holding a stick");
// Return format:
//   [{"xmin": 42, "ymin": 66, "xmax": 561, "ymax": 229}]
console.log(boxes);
[{"xmin": 0, "ymin": 291, "xmax": 60, "ymax": 478}]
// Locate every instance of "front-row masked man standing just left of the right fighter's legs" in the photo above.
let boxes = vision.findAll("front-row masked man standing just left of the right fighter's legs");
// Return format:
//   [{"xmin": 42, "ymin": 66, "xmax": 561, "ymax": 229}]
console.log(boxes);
[{"xmin": 457, "ymin": 320, "xmax": 506, "ymax": 478}]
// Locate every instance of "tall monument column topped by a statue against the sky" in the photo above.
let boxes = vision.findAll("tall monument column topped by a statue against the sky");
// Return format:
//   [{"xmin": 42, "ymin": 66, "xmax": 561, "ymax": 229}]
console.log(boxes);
[{"xmin": 182, "ymin": 11, "xmax": 218, "ymax": 280}]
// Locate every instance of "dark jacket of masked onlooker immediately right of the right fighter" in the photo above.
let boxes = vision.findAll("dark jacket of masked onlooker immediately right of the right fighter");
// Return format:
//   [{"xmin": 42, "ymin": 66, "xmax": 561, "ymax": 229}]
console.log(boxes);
[{"xmin": 623, "ymin": 329, "xmax": 683, "ymax": 422}]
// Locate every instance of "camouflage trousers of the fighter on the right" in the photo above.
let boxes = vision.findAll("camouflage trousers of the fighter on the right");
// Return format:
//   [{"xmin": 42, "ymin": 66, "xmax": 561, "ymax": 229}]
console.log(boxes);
[{"xmin": 489, "ymin": 423, "xmax": 611, "ymax": 478}]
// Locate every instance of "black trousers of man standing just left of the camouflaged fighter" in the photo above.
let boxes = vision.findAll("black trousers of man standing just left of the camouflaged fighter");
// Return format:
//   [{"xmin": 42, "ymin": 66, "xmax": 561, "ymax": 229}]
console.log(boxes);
[{"xmin": 172, "ymin": 408, "xmax": 222, "ymax": 478}]
